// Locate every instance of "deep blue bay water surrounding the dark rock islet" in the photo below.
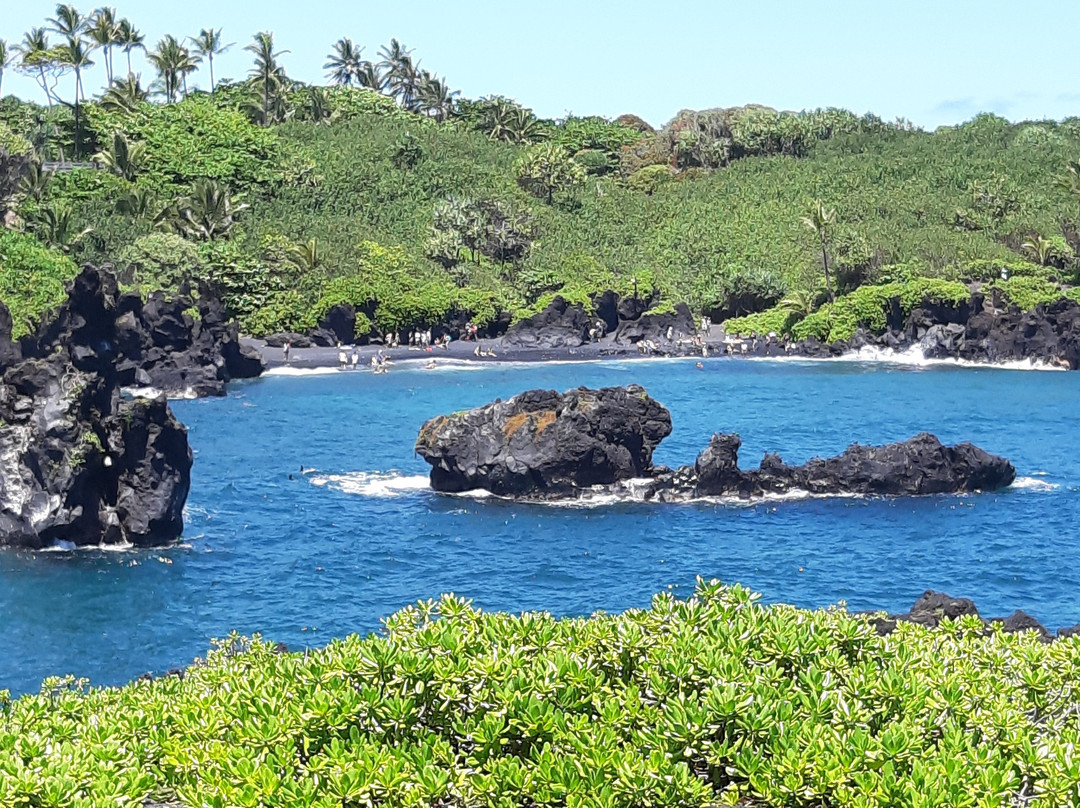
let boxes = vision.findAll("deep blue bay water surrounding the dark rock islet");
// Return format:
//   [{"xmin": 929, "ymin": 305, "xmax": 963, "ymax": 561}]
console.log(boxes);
[{"xmin": 0, "ymin": 360, "xmax": 1080, "ymax": 693}]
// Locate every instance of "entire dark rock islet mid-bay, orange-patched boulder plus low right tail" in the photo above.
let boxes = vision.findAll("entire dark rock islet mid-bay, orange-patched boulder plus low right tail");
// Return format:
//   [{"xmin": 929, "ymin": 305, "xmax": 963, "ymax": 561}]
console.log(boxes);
[{"xmin": 416, "ymin": 386, "xmax": 1016, "ymax": 502}]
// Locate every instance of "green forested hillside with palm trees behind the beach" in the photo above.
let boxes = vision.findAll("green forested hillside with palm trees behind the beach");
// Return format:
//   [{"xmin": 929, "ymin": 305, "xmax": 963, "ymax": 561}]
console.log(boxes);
[{"xmin": 0, "ymin": 5, "xmax": 1080, "ymax": 338}]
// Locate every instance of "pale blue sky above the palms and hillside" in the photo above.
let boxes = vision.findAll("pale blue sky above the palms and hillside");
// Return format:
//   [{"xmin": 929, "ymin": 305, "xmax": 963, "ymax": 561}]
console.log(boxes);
[{"xmin": 0, "ymin": 0, "xmax": 1080, "ymax": 127}]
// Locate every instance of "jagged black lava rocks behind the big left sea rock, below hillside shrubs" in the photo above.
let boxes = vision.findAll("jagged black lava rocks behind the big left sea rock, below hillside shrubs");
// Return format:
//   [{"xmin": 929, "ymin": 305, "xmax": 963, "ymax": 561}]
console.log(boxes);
[{"xmin": 16, "ymin": 265, "xmax": 264, "ymax": 398}]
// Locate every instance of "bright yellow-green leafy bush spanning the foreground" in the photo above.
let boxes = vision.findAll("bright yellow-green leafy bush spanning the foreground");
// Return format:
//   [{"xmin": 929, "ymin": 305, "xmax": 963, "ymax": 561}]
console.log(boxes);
[{"xmin": 0, "ymin": 582, "xmax": 1080, "ymax": 808}]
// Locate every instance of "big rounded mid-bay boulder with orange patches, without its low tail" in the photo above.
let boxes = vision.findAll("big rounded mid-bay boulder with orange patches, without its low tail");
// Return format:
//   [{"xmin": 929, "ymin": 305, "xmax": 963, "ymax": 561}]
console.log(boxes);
[{"xmin": 416, "ymin": 385, "xmax": 672, "ymax": 497}]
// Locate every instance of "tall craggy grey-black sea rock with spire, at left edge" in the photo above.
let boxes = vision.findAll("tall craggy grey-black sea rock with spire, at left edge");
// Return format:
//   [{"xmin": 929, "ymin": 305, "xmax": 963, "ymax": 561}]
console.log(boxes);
[{"xmin": 0, "ymin": 269, "xmax": 191, "ymax": 549}]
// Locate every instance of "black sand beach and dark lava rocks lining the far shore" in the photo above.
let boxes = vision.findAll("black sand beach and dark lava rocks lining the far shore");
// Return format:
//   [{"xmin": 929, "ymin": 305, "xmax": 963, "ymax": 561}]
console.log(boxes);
[{"xmin": 245, "ymin": 292, "xmax": 1080, "ymax": 369}]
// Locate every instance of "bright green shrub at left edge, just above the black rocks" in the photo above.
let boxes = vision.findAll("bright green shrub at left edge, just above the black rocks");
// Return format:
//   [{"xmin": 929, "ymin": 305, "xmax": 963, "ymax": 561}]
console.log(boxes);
[{"xmin": 0, "ymin": 227, "xmax": 78, "ymax": 337}]
